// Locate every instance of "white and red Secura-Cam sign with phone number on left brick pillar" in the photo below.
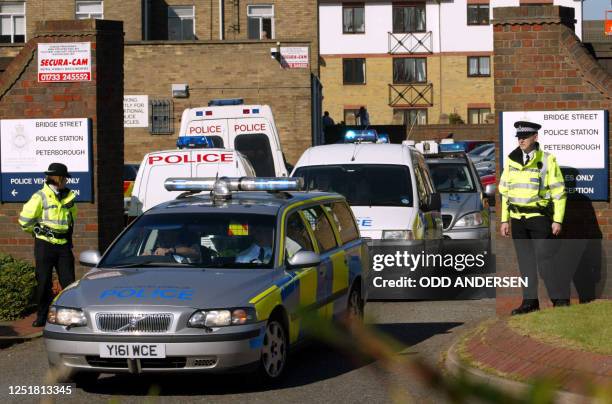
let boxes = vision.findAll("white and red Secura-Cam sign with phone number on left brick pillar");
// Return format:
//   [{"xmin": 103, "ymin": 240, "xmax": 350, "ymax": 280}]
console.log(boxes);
[{"xmin": 38, "ymin": 42, "xmax": 91, "ymax": 83}]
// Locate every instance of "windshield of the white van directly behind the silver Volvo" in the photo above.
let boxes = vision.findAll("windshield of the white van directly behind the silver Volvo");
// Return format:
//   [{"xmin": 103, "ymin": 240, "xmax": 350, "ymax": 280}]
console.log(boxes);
[{"xmin": 294, "ymin": 164, "xmax": 412, "ymax": 207}]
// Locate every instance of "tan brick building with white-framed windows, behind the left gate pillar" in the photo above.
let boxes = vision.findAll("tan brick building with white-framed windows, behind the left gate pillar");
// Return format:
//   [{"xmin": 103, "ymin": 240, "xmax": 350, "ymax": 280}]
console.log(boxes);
[{"xmin": 0, "ymin": 0, "xmax": 320, "ymax": 162}]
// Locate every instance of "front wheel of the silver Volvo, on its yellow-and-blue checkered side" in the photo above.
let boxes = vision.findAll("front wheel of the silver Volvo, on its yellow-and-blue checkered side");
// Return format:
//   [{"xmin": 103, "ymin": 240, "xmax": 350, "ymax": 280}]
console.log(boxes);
[{"xmin": 259, "ymin": 318, "xmax": 289, "ymax": 381}]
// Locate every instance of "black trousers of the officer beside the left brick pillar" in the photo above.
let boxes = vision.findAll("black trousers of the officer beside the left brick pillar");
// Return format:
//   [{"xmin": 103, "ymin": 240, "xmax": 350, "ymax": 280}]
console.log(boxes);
[{"xmin": 34, "ymin": 238, "xmax": 74, "ymax": 319}]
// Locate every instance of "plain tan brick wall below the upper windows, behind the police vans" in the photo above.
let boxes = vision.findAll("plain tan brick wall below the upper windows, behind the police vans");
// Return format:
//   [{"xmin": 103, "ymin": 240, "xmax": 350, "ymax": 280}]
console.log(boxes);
[{"xmin": 125, "ymin": 41, "xmax": 311, "ymax": 162}]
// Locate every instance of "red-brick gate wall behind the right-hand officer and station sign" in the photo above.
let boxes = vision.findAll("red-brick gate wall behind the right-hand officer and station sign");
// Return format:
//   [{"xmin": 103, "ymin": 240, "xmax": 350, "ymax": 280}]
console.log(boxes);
[{"xmin": 493, "ymin": 6, "xmax": 612, "ymax": 313}]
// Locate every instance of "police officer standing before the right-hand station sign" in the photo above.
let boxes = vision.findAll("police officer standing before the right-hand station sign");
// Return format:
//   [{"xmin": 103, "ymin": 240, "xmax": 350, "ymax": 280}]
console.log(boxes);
[{"xmin": 499, "ymin": 121, "xmax": 569, "ymax": 315}]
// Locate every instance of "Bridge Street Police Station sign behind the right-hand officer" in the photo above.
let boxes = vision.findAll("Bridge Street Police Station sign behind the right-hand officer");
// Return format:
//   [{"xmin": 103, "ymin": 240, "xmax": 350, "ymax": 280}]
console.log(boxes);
[{"xmin": 499, "ymin": 110, "xmax": 609, "ymax": 201}]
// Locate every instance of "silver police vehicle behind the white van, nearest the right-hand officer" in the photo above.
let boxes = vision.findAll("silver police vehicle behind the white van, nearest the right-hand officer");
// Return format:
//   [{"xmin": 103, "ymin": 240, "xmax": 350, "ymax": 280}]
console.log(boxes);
[{"xmin": 420, "ymin": 142, "xmax": 491, "ymax": 243}]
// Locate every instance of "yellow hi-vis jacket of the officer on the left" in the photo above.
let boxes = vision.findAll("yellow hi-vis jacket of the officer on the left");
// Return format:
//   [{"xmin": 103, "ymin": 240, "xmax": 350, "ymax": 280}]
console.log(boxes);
[{"xmin": 19, "ymin": 184, "xmax": 77, "ymax": 245}]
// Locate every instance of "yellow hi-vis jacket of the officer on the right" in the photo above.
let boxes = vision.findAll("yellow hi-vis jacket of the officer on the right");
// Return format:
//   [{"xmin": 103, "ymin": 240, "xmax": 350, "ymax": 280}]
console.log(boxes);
[{"xmin": 499, "ymin": 145, "xmax": 566, "ymax": 223}]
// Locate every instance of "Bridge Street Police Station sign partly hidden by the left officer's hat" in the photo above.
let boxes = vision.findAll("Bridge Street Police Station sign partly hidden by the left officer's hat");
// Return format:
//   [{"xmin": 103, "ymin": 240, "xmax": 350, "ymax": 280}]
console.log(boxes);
[{"xmin": 0, "ymin": 118, "xmax": 93, "ymax": 202}]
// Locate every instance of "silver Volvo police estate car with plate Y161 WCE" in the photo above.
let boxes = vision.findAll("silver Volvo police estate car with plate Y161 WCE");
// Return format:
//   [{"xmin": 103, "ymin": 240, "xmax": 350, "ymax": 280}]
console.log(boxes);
[{"xmin": 43, "ymin": 177, "xmax": 368, "ymax": 382}]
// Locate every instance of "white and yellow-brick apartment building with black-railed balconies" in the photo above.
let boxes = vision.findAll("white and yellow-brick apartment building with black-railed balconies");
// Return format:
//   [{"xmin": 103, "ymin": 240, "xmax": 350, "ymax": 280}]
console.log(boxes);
[{"xmin": 319, "ymin": 0, "xmax": 581, "ymax": 125}]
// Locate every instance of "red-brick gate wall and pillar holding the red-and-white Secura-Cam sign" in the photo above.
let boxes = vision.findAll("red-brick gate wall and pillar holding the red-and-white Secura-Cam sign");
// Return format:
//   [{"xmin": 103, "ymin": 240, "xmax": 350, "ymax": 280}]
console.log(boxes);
[{"xmin": 0, "ymin": 20, "xmax": 123, "ymax": 274}]
